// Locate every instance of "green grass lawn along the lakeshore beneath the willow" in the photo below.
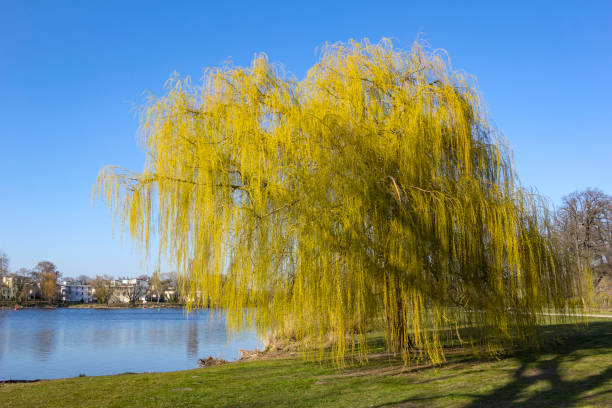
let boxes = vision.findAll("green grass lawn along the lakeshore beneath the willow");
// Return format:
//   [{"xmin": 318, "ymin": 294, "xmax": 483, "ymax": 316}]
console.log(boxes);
[{"xmin": 0, "ymin": 319, "xmax": 612, "ymax": 408}]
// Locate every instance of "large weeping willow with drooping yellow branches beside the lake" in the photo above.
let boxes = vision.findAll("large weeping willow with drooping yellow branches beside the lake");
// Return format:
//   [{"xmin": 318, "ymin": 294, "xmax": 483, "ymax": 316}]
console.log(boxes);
[{"xmin": 96, "ymin": 40, "xmax": 584, "ymax": 363}]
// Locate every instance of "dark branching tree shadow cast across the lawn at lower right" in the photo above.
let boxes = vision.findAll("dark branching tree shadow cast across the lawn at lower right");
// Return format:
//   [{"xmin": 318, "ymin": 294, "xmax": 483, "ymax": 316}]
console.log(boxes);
[{"xmin": 370, "ymin": 321, "xmax": 612, "ymax": 408}]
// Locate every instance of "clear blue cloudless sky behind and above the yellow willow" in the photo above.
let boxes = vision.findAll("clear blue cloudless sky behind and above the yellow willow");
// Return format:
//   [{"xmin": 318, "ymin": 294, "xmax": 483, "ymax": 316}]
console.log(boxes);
[{"xmin": 0, "ymin": 0, "xmax": 612, "ymax": 276}]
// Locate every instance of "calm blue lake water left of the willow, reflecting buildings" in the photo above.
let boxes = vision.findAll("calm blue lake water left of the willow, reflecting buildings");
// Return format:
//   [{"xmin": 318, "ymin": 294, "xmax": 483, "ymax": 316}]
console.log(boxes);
[{"xmin": 0, "ymin": 309, "xmax": 261, "ymax": 380}]
